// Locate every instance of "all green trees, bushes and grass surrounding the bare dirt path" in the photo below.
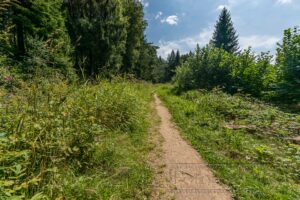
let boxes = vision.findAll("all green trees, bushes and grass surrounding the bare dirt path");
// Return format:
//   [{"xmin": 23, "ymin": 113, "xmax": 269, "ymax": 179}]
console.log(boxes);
[{"xmin": 0, "ymin": 0, "xmax": 300, "ymax": 200}]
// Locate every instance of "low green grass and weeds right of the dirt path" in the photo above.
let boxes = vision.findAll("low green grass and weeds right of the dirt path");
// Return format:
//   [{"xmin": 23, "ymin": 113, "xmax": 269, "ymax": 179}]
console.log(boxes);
[{"xmin": 157, "ymin": 86, "xmax": 300, "ymax": 200}]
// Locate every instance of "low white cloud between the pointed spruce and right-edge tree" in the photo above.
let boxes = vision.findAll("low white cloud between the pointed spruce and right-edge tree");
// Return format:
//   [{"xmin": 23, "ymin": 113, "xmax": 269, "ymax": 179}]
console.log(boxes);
[{"xmin": 240, "ymin": 35, "xmax": 280, "ymax": 50}]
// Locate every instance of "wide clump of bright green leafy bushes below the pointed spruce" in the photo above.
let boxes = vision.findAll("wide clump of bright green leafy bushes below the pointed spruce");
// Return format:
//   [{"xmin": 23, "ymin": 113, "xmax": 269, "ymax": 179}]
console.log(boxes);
[{"xmin": 175, "ymin": 46, "xmax": 277, "ymax": 96}]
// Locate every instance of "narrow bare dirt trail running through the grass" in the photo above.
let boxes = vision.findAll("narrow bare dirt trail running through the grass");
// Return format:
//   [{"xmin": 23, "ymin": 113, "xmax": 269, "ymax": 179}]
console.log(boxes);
[{"xmin": 155, "ymin": 95, "xmax": 232, "ymax": 200}]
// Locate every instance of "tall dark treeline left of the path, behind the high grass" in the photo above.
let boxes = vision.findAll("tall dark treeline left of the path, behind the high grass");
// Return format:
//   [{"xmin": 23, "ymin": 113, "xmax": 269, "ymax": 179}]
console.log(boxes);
[{"xmin": 0, "ymin": 0, "xmax": 159, "ymax": 80}]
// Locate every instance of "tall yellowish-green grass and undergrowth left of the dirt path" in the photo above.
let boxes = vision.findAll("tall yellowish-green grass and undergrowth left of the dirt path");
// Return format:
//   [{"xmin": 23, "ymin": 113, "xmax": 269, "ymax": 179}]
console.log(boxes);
[{"xmin": 0, "ymin": 77, "xmax": 151, "ymax": 199}]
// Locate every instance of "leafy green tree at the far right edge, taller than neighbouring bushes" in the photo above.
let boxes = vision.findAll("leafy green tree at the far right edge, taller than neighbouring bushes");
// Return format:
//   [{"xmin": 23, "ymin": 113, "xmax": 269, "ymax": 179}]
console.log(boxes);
[{"xmin": 276, "ymin": 28, "xmax": 300, "ymax": 103}]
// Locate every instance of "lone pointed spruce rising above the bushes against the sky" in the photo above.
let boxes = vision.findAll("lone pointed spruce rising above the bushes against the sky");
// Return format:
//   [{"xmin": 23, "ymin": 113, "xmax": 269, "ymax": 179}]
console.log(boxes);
[{"xmin": 211, "ymin": 8, "xmax": 239, "ymax": 53}]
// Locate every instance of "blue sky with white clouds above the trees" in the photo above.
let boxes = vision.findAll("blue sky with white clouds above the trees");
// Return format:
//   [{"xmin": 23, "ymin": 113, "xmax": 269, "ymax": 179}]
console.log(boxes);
[{"xmin": 142, "ymin": 0, "xmax": 300, "ymax": 58}]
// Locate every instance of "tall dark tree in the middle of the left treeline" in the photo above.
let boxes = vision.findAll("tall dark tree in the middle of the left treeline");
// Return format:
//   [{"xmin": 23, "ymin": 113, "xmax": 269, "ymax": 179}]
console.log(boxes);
[{"xmin": 65, "ymin": 0, "xmax": 127, "ymax": 76}]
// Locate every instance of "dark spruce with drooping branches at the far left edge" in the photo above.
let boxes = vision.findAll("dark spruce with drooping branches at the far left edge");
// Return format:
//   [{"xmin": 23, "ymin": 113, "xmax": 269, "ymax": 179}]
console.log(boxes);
[{"xmin": 0, "ymin": 0, "xmax": 68, "ymax": 65}]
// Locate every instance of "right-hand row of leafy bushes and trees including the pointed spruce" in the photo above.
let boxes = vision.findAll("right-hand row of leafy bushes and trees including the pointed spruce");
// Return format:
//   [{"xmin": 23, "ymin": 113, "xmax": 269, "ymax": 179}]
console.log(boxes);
[{"xmin": 174, "ymin": 8, "xmax": 300, "ymax": 103}]
